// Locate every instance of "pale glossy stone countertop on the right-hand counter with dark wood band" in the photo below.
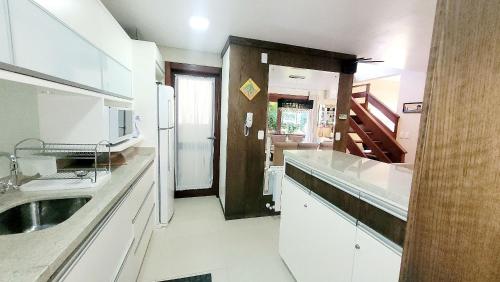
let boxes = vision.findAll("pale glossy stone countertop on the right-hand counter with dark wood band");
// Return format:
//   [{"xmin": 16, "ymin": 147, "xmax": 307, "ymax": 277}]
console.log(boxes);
[{"xmin": 285, "ymin": 150, "xmax": 413, "ymax": 220}]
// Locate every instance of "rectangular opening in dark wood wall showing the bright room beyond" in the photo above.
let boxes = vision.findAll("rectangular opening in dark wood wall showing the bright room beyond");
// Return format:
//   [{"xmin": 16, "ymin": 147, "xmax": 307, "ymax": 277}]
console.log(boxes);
[{"xmin": 266, "ymin": 65, "xmax": 339, "ymax": 166}]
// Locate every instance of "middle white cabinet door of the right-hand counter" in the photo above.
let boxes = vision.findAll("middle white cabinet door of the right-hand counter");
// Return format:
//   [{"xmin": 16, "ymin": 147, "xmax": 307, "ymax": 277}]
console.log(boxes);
[{"xmin": 307, "ymin": 194, "xmax": 356, "ymax": 282}]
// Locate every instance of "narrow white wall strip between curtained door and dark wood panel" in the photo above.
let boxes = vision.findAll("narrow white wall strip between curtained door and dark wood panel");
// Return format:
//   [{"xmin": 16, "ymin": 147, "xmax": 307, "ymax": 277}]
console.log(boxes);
[{"xmin": 219, "ymin": 48, "xmax": 231, "ymax": 209}]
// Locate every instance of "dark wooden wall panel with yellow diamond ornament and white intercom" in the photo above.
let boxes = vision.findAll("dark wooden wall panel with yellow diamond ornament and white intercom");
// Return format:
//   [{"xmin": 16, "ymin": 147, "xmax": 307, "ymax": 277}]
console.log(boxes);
[{"xmin": 225, "ymin": 38, "xmax": 355, "ymax": 219}]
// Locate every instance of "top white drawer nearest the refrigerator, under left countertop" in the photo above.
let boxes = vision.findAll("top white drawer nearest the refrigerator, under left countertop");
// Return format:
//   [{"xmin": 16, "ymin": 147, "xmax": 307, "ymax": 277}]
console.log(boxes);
[{"xmin": 127, "ymin": 166, "xmax": 154, "ymax": 220}]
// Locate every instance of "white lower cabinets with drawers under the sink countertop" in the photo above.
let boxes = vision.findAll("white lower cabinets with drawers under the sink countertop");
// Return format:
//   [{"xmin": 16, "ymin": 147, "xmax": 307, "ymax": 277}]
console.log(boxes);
[{"xmin": 55, "ymin": 167, "xmax": 155, "ymax": 282}]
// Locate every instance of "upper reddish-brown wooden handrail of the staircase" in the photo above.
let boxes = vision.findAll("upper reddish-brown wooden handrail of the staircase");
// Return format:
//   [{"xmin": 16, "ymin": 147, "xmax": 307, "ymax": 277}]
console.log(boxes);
[{"xmin": 352, "ymin": 83, "xmax": 399, "ymax": 138}]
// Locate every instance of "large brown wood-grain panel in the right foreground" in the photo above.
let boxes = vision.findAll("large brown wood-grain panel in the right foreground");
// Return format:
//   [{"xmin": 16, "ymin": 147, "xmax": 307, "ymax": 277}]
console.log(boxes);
[{"xmin": 401, "ymin": 0, "xmax": 500, "ymax": 282}]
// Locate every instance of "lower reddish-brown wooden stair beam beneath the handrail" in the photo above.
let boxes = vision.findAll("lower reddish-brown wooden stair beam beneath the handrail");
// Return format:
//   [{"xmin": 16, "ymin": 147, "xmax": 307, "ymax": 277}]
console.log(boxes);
[{"xmin": 351, "ymin": 97, "xmax": 406, "ymax": 163}]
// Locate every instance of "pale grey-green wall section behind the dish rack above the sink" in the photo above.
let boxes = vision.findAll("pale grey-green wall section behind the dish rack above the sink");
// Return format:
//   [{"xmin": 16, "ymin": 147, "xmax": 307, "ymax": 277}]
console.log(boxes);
[{"xmin": 0, "ymin": 80, "xmax": 40, "ymax": 177}]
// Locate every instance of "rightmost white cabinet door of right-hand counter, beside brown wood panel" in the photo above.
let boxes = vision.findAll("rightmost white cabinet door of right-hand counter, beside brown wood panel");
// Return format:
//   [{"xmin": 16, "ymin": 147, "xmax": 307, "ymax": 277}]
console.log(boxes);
[{"xmin": 352, "ymin": 227, "xmax": 401, "ymax": 282}]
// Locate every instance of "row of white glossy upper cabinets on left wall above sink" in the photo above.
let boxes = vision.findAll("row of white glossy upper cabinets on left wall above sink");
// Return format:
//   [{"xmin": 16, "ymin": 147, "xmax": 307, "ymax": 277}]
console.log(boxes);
[{"xmin": 0, "ymin": 0, "xmax": 133, "ymax": 98}]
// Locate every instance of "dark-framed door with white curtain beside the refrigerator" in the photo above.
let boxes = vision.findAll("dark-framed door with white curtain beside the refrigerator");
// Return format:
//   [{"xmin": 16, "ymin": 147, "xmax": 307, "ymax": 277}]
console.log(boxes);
[{"xmin": 166, "ymin": 63, "xmax": 221, "ymax": 198}]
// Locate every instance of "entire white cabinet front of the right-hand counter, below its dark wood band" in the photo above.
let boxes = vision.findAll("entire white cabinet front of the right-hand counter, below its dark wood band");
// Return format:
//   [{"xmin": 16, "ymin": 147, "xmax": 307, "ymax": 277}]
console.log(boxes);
[{"xmin": 279, "ymin": 177, "xmax": 401, "ymax": 282}]
